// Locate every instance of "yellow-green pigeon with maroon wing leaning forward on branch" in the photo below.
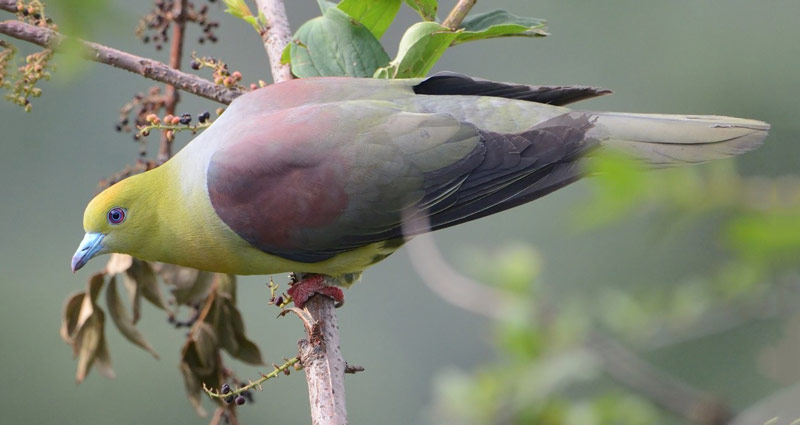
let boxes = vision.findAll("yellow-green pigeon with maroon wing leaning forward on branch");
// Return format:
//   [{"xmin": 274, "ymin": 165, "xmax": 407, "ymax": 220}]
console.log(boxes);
[{"xmin": 72, "ymin": 73, "xmax": 769, "ymax": 307}]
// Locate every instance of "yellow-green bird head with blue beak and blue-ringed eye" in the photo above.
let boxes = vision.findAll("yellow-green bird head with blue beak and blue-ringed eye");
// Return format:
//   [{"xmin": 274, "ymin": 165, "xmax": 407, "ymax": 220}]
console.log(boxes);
[{"xmin": 72, "ymin": 173, "xmax": 153, "ymax": 272}]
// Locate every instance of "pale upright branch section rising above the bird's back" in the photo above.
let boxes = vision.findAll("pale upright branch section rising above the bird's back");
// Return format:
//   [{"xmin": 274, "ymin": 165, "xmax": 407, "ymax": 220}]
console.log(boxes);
[{"xmin": 256, "ymin": 0, "xmax": 292, "ymax": 83}]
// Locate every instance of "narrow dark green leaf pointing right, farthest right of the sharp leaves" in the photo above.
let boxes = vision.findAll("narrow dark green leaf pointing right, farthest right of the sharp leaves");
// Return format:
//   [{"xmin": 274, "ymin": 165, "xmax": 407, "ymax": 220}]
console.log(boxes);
[{"xmin": 453, "ymin": 10, "xmax": 549, "ymax": 44}]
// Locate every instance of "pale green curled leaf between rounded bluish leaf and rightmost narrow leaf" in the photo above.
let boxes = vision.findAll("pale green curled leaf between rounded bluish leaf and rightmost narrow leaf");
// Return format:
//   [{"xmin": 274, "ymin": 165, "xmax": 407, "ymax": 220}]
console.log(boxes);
[{"xmin": 384, "ymin": 22, "xmax": 458, "ymax": 78}]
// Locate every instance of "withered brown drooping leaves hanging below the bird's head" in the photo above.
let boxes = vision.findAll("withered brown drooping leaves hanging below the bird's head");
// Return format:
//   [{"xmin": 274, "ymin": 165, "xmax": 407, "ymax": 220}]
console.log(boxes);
[{"xmin": 61, "ymin": 254, "xmax": 264, "ymax": 406}]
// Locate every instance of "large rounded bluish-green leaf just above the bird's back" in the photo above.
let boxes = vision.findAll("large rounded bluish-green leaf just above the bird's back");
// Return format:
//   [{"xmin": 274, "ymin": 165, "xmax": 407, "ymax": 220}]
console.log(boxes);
[{"xmin": 290, "ymin": 8, "xmax": 389, "ymax": 78}]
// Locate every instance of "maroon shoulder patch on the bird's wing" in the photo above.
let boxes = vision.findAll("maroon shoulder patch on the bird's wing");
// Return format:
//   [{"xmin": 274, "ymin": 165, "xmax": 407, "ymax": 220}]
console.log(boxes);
[{"xmin": 207, "ymin": 107, "xmax": 348, "ymax": 259}]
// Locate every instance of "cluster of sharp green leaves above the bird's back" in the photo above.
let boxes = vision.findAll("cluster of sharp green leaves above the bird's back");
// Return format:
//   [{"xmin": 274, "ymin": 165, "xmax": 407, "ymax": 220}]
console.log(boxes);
[{"xmin": 282, "ymin": 0, "xmax": 547, "ymax": 78}]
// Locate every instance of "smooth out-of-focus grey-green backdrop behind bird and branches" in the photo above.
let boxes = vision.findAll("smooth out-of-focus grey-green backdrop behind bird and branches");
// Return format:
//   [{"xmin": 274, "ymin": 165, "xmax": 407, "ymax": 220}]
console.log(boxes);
[{"xmin": 0, "ymin": 0, "xmax": 800, "ymax": 425}]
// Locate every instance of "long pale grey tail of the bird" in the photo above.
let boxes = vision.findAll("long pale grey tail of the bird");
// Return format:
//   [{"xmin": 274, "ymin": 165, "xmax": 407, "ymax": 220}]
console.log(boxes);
[{"xmin": 586, "ymin": 112, "xmax": 770, "ymax": 167}]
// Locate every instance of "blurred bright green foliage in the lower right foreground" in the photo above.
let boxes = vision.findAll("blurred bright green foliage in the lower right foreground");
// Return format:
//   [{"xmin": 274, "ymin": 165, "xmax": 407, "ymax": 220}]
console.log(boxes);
[{"xmin": 433, "ymin": 157, "xmax": 800, "ymax": 425}]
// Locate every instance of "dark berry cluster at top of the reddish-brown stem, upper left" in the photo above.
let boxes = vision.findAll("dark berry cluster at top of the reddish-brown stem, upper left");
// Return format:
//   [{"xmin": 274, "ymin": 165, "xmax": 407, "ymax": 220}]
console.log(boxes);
[{"xmin": 136, "ymin": 0, "xmax": 219, "ymax": 50}]
